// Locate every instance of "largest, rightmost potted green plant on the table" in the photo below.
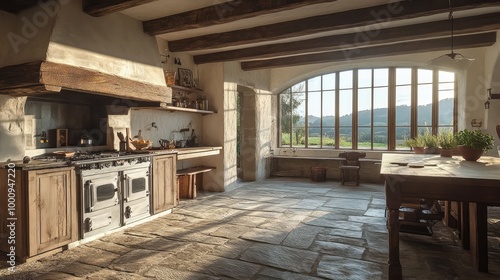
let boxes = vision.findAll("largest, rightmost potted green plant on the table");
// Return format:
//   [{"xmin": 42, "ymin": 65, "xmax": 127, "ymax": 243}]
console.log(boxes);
[{"xmin": 455, "ymin": 129, "xmax": 494, "ymax": 161}]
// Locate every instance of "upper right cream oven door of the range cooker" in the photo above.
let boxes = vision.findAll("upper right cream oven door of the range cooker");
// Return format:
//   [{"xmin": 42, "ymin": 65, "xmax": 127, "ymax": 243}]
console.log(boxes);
[{"xmin": 123, "ymin": 167, "xmax": 149, "ymax": 202}]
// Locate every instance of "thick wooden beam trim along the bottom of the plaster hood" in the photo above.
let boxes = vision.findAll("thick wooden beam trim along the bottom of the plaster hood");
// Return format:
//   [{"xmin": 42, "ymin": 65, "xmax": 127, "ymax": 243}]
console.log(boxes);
[{"xmin": 0, "ymin": 61, "xmax": 172, "ymax": 104}]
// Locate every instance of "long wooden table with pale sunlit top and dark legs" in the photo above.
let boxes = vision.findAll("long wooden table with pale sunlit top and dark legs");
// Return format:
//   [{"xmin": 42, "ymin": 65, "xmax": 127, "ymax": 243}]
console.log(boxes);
[{"xmin": 380, "ymin": 153, "xmax": 500, "ymax": 279}]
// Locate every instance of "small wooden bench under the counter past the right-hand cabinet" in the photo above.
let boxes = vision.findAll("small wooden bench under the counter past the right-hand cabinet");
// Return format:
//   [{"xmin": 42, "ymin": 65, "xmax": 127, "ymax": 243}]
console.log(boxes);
[{"xmin": 177, "ymin": 166, "xmax": 215, "ymax": 199}]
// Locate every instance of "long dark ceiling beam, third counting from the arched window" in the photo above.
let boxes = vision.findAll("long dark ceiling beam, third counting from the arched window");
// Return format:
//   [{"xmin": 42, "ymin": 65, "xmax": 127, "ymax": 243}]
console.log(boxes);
[{"xmin": 168, "ymin": 0, "xmax": 500, "ymax": 52}]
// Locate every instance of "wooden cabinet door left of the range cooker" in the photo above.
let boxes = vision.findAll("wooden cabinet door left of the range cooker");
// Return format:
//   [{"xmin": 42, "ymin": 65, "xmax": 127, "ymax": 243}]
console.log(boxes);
[{"xmin": 28, "ymin": 168, "xmax": 78, "ymax": 256}]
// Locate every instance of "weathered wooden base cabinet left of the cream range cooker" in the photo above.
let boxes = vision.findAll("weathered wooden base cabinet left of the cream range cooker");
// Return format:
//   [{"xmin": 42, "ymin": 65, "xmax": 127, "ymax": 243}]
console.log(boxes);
[{"xmin": 0, "ymin": 167, "xmax": 78, "ymax": 261}]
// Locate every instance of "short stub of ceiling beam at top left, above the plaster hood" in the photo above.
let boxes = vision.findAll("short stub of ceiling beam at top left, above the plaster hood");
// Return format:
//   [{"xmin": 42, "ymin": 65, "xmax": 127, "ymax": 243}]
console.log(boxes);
[{"xmin": 82, "ymin": 0, "xmax": 155, "ymax": 17}]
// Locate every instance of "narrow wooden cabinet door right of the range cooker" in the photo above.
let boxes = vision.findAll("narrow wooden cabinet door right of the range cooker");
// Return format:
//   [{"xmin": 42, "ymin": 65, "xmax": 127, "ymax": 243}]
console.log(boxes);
[{"xmin": 152, "ymin": 155, "xmax": 178, "ymax": 214}]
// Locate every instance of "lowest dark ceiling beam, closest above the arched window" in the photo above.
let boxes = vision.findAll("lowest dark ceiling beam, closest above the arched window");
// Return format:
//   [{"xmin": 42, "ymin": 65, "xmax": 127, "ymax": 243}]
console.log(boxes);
[{"xmin": 241, "ymin": 32, "xmax": 497, "ymax": 71}]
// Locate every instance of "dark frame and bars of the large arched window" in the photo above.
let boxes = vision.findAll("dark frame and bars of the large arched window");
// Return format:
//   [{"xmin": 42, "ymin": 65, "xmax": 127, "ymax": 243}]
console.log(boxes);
[{"xmin": 277, "ymin": 66, "xmax": 458, "ymax": 151}]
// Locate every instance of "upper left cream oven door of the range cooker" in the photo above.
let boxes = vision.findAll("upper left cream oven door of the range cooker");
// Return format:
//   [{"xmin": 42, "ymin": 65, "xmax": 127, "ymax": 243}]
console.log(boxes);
[{"xmin": 83, "ymin": 172, "xmax": 120, "ymax": 213}]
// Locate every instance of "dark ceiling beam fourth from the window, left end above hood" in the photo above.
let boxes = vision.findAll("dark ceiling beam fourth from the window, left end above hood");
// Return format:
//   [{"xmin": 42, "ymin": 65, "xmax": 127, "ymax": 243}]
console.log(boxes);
[{"xmin": 143, "ymin": 0, "xmax": 337, "ymax": 36}]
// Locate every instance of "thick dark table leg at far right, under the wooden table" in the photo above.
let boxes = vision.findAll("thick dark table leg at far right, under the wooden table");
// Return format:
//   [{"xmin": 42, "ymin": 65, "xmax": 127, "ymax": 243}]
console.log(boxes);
[{"xmin": 469, "ymin": 203, "xmax": 488, "ymax": 272}]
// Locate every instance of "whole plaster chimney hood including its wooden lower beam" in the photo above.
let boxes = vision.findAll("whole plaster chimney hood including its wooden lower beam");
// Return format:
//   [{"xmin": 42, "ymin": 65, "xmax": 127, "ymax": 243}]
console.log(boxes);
[{"xmin": 0, "ymin": 0, "xmax": 172, "ymax": 103}]
